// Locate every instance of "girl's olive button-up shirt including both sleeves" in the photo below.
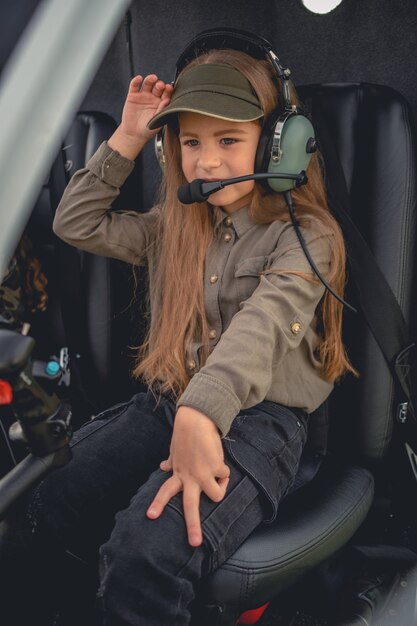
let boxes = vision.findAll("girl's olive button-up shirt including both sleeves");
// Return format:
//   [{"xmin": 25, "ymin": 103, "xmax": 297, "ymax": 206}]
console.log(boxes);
[{"xmin": 54, "ymin": 143, "xmax": 333, "ymax": 435}]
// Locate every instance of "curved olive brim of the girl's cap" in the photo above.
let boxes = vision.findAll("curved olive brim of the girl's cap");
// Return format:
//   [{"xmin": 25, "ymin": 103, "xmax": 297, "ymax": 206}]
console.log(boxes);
[{"xmin": 148, "ymin": 91, "xmax": 263, "ymax": 130}]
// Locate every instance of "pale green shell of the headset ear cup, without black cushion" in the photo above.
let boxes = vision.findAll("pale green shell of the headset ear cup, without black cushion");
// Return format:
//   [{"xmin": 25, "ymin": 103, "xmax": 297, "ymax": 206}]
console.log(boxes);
[{"xmin": 267, "ymin": 115, "xmax": 315, "ymax": 193}]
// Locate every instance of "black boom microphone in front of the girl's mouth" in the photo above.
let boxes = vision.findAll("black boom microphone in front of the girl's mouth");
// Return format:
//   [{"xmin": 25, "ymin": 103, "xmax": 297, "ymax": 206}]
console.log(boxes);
[{"xmin": 177, "ymin": 170, "xmax": 307, "ymax": 204}]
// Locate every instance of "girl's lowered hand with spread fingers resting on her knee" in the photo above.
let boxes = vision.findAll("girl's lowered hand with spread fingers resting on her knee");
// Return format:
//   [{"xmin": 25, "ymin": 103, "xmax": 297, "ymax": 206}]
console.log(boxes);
[{"xmin": 147, "ymin": 406, "xmax": 230, "ymax": 547}]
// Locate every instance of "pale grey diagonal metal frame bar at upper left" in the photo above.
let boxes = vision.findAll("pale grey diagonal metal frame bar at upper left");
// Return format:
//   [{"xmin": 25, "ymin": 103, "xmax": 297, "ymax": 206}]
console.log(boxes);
[{"xmin": 0, "ymin": 0, "xmax": 130, "ymax": 281}]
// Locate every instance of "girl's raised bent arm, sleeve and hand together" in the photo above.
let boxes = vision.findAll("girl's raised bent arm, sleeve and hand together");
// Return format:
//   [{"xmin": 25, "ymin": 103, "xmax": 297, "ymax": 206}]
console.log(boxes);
[{"xmin": 53, "ymin": 74, "xmax": 172, "ymax": 264}]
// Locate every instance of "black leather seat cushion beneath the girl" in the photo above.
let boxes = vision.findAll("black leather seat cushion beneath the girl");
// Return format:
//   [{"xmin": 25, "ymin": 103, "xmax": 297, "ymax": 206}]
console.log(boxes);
[{"xmin": 201, "ymin": 462, "xmax": 374, "ymax": 610}]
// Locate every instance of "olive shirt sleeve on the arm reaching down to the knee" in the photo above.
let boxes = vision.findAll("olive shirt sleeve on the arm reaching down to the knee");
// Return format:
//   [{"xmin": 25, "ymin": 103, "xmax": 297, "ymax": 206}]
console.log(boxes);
[{"xmin": 178, "ymin": 224, "xmax": 332, "ymax": 435}]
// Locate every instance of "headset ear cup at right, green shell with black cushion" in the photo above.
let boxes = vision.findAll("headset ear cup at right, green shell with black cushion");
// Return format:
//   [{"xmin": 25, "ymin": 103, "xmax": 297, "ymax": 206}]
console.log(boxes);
[{"xmin": 255, "ymin": 111, "xmax": 316, "ymax": 193}]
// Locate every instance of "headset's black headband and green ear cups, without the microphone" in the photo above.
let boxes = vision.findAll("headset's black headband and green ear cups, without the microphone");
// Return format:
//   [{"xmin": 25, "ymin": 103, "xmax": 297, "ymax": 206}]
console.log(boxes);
[{"xmin": 155, "ymin": 28, "xmax": 317, "ymax": 192}]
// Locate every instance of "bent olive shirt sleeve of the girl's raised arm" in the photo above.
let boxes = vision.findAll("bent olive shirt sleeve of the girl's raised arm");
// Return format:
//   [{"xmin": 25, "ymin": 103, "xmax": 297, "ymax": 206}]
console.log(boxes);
[{"xmin": 53, "ymin": 142, "xmax": 158, "ymax": 264}]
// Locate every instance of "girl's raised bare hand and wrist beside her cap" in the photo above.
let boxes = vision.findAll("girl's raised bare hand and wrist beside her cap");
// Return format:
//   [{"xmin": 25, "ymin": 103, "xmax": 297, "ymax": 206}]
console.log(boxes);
[{"xmin": 108, "ymin": 74, "xmax": 173, "ymax": 159}]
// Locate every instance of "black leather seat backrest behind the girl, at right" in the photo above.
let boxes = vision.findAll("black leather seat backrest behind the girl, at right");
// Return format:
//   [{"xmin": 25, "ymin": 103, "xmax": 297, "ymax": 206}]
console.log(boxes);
[{"xmin": 298, "ymin": 83, "xmax": 417, "ymax": 460}]
